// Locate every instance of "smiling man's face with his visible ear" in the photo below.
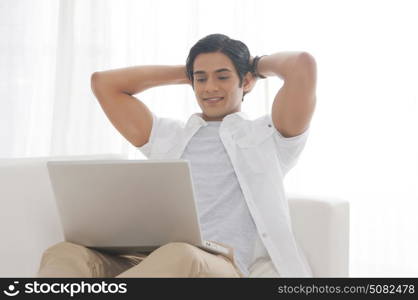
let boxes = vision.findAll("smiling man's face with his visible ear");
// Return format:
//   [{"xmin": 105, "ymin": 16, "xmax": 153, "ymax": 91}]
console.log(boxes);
[{"xmin": 193, "ymin": 52, "xmax": 252, "ymax": 121}]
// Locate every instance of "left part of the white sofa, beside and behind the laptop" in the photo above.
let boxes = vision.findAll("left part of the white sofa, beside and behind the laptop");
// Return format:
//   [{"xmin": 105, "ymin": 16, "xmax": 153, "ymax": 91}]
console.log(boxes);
[{"xmin": 0, "ymin": 154, "xmax": 127, "ymax": 277}]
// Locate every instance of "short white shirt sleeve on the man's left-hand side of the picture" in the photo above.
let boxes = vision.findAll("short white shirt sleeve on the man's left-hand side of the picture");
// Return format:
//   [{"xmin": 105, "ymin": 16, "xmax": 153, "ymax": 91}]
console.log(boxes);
[{"xmin": 136, "ymin": 112, "xmax": 183, "ymax": 158}]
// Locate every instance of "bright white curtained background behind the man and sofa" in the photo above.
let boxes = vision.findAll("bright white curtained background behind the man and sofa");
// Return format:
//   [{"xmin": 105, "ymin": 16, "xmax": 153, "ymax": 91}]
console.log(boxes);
[{"xmin": 0, "ymin": 0, "xmax": 418, "ymax": 277}]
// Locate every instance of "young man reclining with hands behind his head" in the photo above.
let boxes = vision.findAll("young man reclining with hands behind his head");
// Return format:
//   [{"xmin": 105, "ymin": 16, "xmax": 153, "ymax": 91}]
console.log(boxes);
[{"xmin": 38, "ymin": 34, "xmax": 316, "ymax": 277}]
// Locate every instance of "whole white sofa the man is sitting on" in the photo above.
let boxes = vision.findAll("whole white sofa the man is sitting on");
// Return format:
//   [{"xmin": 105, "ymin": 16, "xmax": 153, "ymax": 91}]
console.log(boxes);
[{"xmin": 0, "ymin": 154, "xmax": 349, "ymax": 277}]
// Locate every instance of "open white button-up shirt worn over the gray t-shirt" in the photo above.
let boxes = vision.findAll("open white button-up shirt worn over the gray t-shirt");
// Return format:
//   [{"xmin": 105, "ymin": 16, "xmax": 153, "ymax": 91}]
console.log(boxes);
[{"xmin": 138, "ymin": 112, "xmax": 312, "ymax": 277}]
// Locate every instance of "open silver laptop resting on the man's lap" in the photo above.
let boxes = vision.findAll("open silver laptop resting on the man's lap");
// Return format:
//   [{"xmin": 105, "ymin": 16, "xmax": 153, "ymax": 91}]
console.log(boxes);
[{"xmin": 46, "ymin": 159, "xmax": 229, "ymax": 255}]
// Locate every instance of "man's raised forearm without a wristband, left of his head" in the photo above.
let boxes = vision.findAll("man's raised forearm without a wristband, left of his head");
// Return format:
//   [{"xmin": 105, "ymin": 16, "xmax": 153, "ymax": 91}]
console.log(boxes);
[{"xmin": 93, "ymin": 65, "xmax": 190, "ymax": 95}]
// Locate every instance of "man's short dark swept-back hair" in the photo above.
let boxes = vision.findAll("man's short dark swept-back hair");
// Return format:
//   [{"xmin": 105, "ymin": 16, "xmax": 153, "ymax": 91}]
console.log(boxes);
[{"xmin": 186, "ymin": 33, "xmax": 251, "ymax": 101}]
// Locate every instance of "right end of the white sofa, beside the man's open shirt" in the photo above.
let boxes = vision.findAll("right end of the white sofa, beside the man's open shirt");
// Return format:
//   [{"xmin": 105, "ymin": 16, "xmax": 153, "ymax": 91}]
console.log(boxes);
[{"xmin": 288, "ymin": 195, "xmax": 349, "ymax": 277}]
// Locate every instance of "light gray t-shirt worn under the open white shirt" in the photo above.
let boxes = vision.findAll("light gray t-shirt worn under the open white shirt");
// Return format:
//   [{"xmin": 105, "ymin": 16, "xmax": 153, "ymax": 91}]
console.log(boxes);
[{"xmin": 181, "ymin": 121, "xmax": 258, "ymax": 276}]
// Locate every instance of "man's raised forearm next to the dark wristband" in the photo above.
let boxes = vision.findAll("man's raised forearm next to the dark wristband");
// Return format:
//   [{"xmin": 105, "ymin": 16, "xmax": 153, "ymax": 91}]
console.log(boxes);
[{"xmin": 257, "ymin": 51, "xmax": 307, "ymax": 80}]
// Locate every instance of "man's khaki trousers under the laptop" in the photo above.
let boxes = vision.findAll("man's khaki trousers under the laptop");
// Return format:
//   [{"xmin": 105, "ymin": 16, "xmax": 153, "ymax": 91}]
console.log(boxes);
[{"xmin": 37, "ymin": 242, "xmax": 244, "ymax": 278}]
